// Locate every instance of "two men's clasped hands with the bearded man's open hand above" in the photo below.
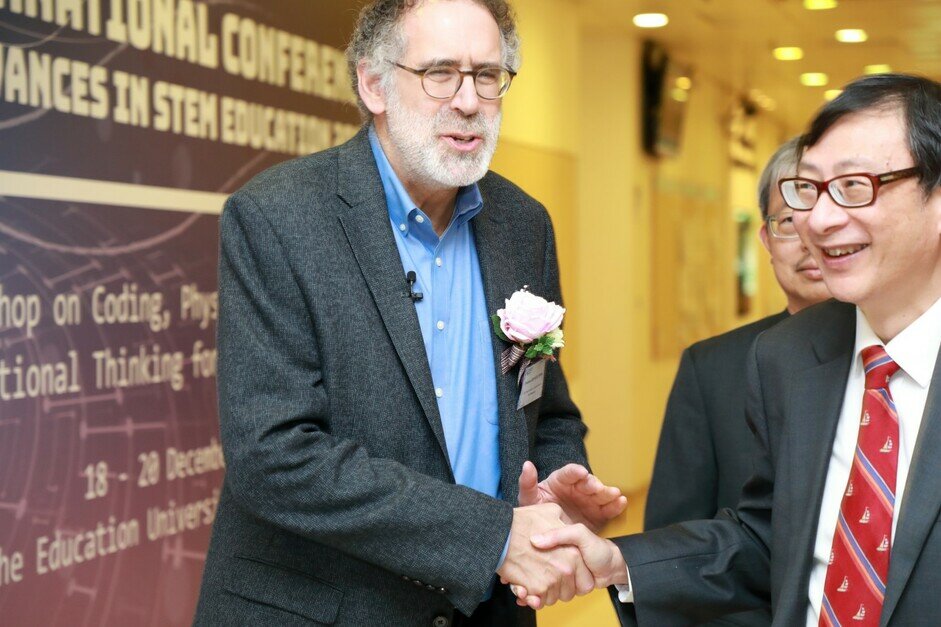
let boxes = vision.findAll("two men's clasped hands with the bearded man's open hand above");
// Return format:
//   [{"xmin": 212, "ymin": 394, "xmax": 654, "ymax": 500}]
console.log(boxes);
[{"xmin": 497, "ymin": 462, "xmax": 627, "ymax": 609}]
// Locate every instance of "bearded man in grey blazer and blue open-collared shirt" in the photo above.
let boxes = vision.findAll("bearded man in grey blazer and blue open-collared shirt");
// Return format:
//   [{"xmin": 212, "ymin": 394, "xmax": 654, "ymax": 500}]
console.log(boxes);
[{"xmin": 195, "ymin": 0, "xmax": 624, "ymax": 627}]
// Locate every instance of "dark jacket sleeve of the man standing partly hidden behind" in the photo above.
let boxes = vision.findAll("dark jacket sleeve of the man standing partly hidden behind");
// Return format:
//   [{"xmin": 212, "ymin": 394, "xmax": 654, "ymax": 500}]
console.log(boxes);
[{"xmin": 644, "ymin": 349, "xmax": 719, "ymax": 529}]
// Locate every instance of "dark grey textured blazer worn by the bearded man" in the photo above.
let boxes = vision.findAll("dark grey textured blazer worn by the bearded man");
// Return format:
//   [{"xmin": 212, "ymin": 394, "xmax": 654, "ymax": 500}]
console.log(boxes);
[{"xmin": 196, "ymin": 131, "xmax": 586, "ymax": 626}]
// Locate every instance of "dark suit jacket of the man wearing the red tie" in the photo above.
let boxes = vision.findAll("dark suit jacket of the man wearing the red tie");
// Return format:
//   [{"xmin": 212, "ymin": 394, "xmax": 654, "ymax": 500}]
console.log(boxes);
[{"xmin": 615, "ymin": 301, "xmax": 941, "ymax": 627}]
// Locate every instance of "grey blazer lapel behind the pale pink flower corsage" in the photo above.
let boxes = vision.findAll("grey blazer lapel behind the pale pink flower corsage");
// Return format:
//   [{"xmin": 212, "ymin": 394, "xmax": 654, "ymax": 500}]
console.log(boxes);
[{"xmin": 472, "ymin": 181, "xmax": 534, "ymax": 503}]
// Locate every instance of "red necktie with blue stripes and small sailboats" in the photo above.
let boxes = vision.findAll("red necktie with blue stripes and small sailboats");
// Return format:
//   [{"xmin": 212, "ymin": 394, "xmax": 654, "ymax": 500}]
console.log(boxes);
[{"xmin": 820, "ymin": 346, "xmax": 899, "ymax": 627}]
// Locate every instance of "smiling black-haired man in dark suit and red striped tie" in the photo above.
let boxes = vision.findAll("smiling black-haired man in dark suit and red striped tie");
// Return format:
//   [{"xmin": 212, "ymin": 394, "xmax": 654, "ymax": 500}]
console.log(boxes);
[{"xmin": 516, "ymin": 74, "xmax": 941, "ymax": 627}]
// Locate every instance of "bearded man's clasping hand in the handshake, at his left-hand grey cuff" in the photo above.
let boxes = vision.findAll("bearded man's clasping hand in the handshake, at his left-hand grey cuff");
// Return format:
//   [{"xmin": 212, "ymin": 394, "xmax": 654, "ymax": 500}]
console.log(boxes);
[{"xmin": 497, "ymin": 503, "xmax": 595, "ymax": 609}]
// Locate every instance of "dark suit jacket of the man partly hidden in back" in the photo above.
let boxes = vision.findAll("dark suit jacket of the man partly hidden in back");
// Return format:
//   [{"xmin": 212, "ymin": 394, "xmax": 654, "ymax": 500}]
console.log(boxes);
[{"xmin": 644, "ymin": 311, "xmax": 788, "ymax": 627}]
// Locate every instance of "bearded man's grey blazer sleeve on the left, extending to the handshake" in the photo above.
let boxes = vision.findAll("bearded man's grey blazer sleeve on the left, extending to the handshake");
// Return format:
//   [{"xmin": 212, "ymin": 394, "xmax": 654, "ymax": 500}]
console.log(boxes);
[{"xmin": 218, "ymin": 193, "xmax": 512, "ymax": 614}]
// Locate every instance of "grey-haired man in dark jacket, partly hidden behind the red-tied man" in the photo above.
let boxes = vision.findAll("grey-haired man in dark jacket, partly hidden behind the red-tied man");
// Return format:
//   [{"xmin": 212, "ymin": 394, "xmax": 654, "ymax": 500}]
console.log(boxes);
[{"xmin": 644, "ymin": 138, "xmax": 830, "ymax": 626}]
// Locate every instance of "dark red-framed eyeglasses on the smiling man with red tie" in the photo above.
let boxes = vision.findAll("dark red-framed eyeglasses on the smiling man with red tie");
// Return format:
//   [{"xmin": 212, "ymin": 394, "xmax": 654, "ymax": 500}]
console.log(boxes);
[{"xmin": 778, "ymin": 168, "xmax": 918, "ymax": 211}]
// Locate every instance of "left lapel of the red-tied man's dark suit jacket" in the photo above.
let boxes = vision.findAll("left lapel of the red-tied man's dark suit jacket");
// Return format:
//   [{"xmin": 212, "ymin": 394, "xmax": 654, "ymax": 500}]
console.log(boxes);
[{"xmin": 780, "ymin": 309, "xmax": 855, "ymax": 624}]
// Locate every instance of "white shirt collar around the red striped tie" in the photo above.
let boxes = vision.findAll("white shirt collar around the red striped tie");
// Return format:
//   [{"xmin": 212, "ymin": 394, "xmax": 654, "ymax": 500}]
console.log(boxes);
[{"xmin": 853, "ymin": 299, "xmax": 941, "ymax": 389}]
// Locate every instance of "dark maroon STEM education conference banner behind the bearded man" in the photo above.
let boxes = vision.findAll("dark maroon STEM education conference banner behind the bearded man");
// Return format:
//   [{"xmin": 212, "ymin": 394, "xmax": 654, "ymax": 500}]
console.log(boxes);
[{"xmin": 0, "ymin": 0, "xmax": 360, "ymax": 626}]
